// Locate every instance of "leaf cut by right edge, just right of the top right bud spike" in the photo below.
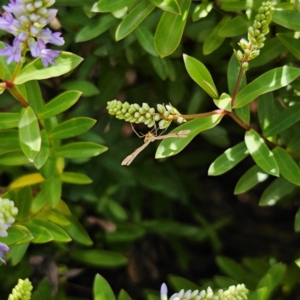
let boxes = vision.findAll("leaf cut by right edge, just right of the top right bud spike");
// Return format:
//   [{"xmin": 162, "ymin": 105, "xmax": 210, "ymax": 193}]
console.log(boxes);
[{"xmin": 272, "ymin": 10, "xmax": 300, "ymax": 31}]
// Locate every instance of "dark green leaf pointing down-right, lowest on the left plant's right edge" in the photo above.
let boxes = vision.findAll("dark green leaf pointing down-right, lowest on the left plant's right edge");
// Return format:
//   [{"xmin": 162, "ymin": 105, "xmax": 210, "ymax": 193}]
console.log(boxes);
[{"xmin": 62, "ymin": 215, "xmax": 93, "ymax": 246}]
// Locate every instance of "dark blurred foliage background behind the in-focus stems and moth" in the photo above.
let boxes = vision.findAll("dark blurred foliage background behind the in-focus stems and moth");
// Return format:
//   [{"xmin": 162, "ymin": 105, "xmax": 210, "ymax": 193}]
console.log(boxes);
[{"xmin": 0, "ymin": 0, "xmax": 300, "ymax": 300}]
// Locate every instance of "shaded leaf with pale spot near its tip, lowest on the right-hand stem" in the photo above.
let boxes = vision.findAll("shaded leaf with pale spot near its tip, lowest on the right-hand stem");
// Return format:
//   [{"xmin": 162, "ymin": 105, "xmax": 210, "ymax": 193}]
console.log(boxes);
[{"xmin": 259, "ymin": 177, "xmax": 296, "ymax": 206}]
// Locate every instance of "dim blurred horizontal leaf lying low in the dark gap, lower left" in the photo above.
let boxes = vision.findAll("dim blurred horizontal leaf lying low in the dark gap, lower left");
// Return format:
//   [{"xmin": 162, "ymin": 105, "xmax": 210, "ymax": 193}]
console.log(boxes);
[{"xmin": 71, "ymin": 249, "xmax": 127, "ymax": 268}]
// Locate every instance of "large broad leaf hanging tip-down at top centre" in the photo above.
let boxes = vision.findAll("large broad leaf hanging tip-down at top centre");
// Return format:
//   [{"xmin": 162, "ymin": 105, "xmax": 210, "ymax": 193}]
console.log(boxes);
[{"xmin": 154, "ymin": 0, "xmax": 191, "ymax": 57}]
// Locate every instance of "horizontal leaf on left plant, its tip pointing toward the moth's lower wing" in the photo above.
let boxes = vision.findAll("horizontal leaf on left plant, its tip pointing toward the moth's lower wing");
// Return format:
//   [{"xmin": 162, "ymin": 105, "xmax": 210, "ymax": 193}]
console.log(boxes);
[{"xmin": 56, "ymin": 142, "xmax": 108, "ymax": 158}]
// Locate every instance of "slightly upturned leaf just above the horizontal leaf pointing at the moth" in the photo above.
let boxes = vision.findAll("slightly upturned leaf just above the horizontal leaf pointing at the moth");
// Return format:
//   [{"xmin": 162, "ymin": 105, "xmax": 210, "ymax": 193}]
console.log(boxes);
[{"xmin": 49, "ymin": 117, "xmax": 96, "ymax": 139}]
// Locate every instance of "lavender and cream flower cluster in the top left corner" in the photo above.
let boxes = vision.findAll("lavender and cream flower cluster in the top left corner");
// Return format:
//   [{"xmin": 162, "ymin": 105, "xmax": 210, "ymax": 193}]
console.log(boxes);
[{"xmin": 0, "ymin": 0, "xmax": 65, "ymax": 67}]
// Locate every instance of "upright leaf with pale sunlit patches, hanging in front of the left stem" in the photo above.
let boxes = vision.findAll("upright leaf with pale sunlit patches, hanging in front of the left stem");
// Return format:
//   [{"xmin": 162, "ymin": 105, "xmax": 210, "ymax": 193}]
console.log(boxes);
[{"xmin": 19, "ymin": 106, "xmax": 42, "ymax": 162}]
